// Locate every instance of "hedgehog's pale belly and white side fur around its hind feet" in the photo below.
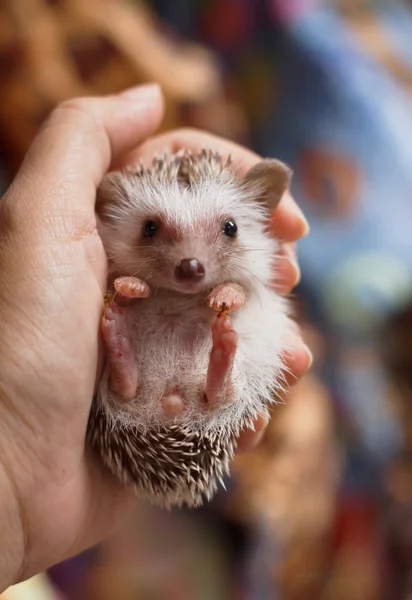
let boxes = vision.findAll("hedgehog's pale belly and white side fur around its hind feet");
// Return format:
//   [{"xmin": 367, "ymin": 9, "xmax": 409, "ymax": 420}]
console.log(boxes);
[{"xmin": 98, "ymin": 285, "xmax": 288, "ymax": 433}]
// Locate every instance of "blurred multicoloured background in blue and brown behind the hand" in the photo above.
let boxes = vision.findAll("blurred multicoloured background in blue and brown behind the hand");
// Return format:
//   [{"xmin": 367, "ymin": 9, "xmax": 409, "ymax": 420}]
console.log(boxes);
[{"xmin": 4, "ymin": 0, "xmax": 412, "ymax": 600}]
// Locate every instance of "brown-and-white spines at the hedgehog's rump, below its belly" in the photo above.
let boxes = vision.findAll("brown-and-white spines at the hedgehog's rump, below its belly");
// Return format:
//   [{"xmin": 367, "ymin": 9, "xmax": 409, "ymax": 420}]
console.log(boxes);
[{"xmin": 87, "ymin": 408, "xmax": 236, "ymax": 508}]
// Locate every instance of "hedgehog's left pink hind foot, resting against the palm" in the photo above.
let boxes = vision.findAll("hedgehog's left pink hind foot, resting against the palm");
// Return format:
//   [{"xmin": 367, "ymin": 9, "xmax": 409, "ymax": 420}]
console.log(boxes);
[{"xmin": 101, "ymin": 302, "xmax": 138, "ymax": 398}]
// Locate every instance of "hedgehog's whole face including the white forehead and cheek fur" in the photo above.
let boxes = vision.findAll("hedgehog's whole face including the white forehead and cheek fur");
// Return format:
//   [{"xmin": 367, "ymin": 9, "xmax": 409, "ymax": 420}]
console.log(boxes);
[{"xmin": 96, "ymin": 156, "xmax": 292, "ymax": 294}]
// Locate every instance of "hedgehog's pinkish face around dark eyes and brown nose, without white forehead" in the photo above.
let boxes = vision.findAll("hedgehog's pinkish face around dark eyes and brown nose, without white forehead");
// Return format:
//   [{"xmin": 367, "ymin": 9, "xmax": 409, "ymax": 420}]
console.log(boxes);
[{"xmin": 116, "ymin": 210, "xmax": 248, "ymax": 294}]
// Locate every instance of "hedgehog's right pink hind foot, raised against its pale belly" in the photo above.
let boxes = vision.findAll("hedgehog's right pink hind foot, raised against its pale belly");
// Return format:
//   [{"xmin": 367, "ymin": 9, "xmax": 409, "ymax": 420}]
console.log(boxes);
[{"xmin": 205, "ymin": 313, "xmax": 238, "ymax": 406}]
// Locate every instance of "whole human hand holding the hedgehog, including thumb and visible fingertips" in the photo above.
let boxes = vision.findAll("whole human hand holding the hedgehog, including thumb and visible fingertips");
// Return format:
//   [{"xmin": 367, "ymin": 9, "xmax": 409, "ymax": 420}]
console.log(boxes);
[{"xmin": 0, "ymin": 86, "xmax": 310, "ymax": 590}]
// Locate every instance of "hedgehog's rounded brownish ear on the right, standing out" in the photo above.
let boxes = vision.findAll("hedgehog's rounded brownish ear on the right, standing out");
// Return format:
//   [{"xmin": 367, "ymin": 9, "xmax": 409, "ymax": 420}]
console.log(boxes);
[{"xmin": 243, "ymin": 158, "xmax": 292, "ymax": 213}]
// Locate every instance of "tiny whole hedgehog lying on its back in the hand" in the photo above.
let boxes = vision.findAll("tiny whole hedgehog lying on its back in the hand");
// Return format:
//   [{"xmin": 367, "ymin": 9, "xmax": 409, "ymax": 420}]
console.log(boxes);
[{"xmin": 87, "ymin": 150, "xmax": 292, "ymax": 509}]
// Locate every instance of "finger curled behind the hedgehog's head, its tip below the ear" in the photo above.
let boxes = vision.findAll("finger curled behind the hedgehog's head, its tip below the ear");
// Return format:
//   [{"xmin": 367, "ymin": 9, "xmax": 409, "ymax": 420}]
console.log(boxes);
[{"xmin": 121, "ymin": 129, "xmax": 309, "ymax": 242}]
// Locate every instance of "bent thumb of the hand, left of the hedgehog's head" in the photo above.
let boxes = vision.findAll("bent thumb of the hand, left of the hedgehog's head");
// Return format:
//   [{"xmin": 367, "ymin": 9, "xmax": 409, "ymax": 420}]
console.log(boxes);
[{"xmin": 6, "ymin": 85, "xmax": 163, "ymax": 233}]
